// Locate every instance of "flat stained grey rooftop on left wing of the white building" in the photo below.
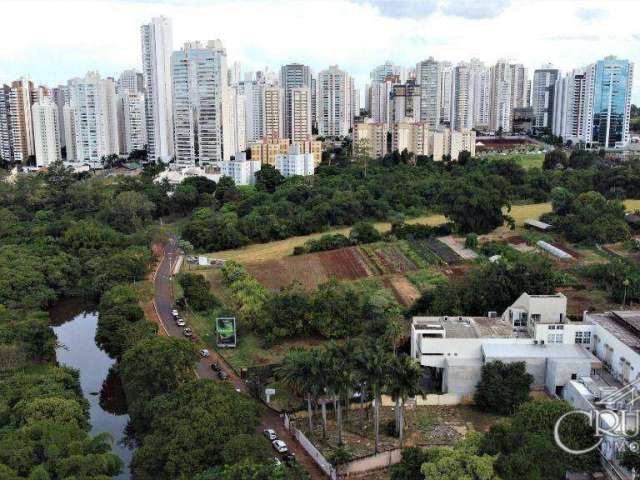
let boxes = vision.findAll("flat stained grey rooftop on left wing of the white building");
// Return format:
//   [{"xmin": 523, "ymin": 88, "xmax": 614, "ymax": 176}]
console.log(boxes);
[{"xmin": 413, "ymin": 316, "xmax": 526, "ymax": 338}]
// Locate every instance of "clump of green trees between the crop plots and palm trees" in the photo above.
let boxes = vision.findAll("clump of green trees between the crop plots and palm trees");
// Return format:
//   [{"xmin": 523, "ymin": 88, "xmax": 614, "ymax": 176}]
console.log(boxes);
[{"xmin": 222, "ymin": 261, "xmax": 401, "ymax": 346}]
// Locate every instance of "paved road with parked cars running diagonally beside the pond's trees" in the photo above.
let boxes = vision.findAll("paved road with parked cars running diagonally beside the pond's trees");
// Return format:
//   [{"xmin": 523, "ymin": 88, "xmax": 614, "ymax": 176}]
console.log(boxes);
[{"xmin": 154, "ymin": 238, "xmax": 325, "ymax": 480}]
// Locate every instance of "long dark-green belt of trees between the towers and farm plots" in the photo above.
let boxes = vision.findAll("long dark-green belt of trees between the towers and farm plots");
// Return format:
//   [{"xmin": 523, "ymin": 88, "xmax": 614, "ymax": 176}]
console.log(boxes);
[{"xmin": 172, "ymin": 153, "xmax": 640, "ymax": 251}]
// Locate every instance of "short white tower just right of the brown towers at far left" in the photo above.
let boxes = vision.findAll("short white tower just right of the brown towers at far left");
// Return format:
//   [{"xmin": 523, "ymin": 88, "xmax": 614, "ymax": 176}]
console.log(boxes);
[{"xmin": 31, "ymin": 97, "xmax": 62, "ymax": 167}]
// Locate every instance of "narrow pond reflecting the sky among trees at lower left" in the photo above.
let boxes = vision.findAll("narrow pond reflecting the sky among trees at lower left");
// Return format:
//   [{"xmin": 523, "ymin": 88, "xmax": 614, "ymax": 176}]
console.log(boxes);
[{"xmin": 50, "ymin": 301, "xmax": 133, "ymax": 480}]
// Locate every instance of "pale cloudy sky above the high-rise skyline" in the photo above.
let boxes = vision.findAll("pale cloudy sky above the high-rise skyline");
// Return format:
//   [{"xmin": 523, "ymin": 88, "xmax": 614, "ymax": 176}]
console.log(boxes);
[{"xmin": 0, "ymin": 0, "xmax": 640, "ymax": 104}]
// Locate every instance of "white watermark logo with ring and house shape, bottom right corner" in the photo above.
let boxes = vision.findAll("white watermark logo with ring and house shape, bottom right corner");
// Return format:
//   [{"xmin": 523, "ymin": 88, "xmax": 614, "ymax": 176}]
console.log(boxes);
[{"xmin": 553, "ymin": 379, "xmax": 640, "ymax": 455}]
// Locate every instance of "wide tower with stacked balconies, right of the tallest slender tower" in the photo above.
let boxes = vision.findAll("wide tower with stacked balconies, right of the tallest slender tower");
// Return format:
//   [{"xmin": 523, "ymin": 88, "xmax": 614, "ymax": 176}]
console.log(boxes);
[{"xmin": 172, "ymin": 40, "xmax": 228, "ymax": 165}]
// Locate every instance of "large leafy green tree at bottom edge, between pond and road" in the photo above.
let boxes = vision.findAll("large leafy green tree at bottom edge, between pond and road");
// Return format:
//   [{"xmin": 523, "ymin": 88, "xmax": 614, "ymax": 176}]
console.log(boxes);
[{"xmin": 131, "ymin": 380, "xmax": 266, "ymax": 480}]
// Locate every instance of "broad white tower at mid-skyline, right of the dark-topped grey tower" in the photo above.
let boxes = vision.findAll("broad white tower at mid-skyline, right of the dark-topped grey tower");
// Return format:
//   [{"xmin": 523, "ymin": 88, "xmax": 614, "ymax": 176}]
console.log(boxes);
[{"xmin": 318, "ymin": 65, "xmax": 353, "ymax": 137}]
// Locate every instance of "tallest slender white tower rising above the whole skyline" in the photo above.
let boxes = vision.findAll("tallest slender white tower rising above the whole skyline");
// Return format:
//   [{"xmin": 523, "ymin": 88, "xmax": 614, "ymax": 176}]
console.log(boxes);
[{"xmin": 141, "ymin": 17, "xmax": 174, "ymax": 162}]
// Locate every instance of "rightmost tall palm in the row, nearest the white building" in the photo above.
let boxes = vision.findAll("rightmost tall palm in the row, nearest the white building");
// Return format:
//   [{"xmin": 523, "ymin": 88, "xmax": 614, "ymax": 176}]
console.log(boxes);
[{"xmin": 387, "ymin": 355, "xmax": 422, "ymax": 448}]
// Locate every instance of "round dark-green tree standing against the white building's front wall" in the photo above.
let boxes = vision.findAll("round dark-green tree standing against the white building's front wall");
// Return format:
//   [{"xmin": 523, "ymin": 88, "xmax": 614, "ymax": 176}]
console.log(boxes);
[{"xmin": 473, "ymin": 361, "xmax": 533, "ymax": 415}]
